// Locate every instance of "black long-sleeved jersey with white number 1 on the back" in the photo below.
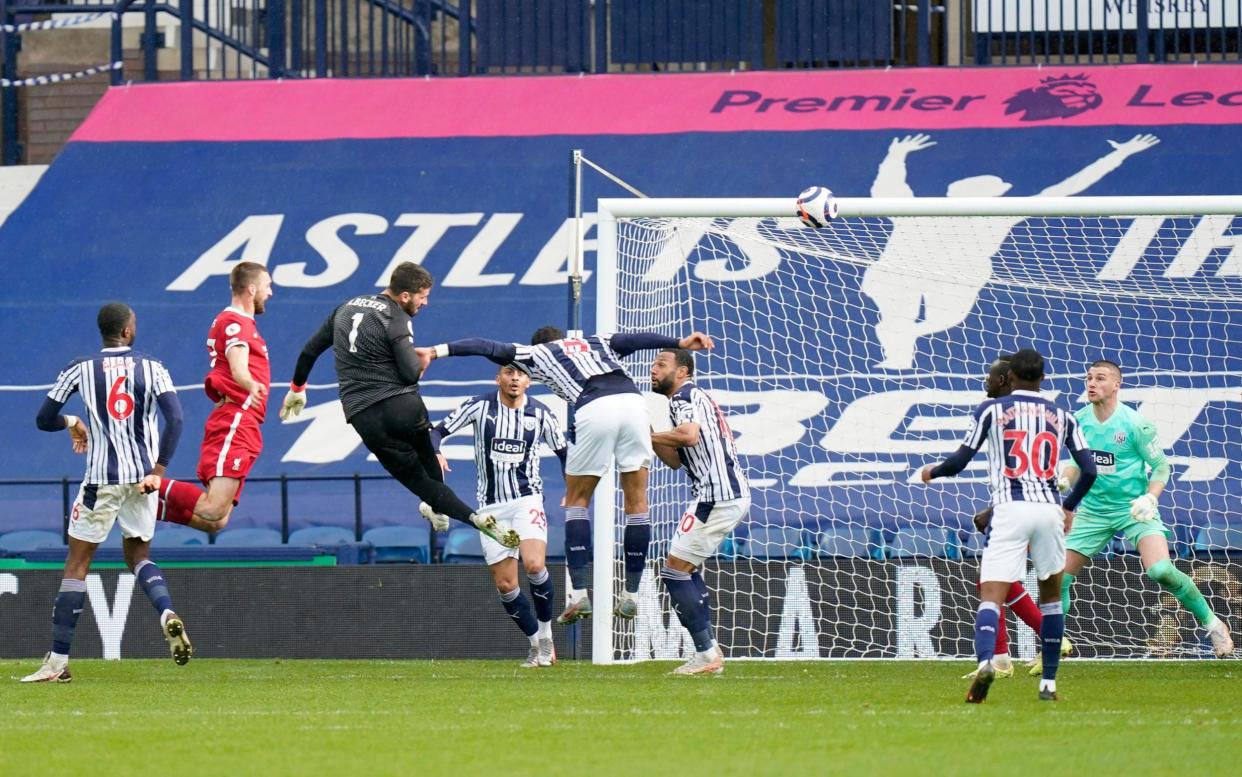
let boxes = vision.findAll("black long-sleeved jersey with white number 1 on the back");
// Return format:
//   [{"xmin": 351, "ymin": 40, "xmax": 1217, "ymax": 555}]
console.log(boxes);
[{"xmin": 293, "ymin": 294, "xmax": 422, "ymax": 421}]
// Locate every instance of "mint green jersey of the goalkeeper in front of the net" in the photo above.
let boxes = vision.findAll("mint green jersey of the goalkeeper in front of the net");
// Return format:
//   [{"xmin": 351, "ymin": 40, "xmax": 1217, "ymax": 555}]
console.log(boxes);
[{"xmin": 1074, "ymin": 402, "xmax": 1165, "ymax": 518}]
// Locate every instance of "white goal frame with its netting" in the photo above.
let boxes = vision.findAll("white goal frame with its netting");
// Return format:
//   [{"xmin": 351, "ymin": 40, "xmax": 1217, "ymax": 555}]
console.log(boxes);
[{"xmin": 591, "ymin": 197, "xmax": 1242, "ymax": 663}]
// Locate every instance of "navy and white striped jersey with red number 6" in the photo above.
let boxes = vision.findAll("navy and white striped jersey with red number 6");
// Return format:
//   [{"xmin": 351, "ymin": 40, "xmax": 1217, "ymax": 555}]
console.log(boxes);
[{"xmin": 47, "ymin": 348, "xmax": 176, "ymax": 485}]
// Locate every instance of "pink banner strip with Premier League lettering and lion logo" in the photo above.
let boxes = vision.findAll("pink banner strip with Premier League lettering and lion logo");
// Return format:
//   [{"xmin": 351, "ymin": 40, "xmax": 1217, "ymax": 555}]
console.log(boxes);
[{"xmin": 73, "ymin": 65, "xmax": 1242, "ymax": 141}]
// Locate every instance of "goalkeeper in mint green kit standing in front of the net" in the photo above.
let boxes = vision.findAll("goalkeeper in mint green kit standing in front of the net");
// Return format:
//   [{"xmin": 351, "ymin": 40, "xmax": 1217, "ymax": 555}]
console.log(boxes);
[{"xmin": 1061, "ymin": 359, "xmax": 1233, "ymax": 658}]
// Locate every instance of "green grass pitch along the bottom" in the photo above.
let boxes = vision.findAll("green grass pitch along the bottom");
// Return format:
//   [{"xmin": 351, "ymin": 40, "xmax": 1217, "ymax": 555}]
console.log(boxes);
[{"xmin": 0, "ymin": 660, "xmax": 1242, "ymax": 777}]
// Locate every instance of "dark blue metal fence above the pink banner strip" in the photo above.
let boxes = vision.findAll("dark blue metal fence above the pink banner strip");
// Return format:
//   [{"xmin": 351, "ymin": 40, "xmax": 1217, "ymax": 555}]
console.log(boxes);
[{"xmin": 0, "ymin": 0, "xmax": 1242, "ymax": 81}]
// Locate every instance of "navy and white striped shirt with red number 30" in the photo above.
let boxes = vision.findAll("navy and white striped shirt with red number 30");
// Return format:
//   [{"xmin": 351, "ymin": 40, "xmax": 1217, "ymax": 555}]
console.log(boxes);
[{"xmin": 932, "ymin": 390, "xmax": 1088, "ymax": 509}]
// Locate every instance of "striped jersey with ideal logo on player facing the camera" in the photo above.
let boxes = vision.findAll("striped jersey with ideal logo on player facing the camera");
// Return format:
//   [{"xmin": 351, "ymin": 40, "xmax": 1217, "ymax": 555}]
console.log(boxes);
[{"xmin": 432, "ymin": 392, "xmax": 568, "ymax": 506}]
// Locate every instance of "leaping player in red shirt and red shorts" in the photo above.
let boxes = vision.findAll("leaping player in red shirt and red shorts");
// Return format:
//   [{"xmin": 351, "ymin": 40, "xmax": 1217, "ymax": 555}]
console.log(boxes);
[{"xmin": 158, "ymin": 262, "xmax": 272, "ymax": 532}]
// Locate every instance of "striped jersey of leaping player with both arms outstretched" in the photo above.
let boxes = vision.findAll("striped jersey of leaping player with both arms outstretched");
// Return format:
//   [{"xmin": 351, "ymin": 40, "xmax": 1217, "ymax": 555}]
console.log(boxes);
[{"xmin": 513, "ymin": 335, "xmax": 638, "ymax": 407}]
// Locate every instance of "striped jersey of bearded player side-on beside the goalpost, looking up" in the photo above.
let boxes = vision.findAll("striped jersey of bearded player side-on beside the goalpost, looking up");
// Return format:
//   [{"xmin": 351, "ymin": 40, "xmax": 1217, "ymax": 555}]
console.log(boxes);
[{"xmin": 668, "ymin": 382, "xmax": 750, "ymax": 501}]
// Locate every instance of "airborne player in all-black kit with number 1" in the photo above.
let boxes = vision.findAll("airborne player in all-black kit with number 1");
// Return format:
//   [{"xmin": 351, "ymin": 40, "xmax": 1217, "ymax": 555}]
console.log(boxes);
[{"xmin": 281, "ymin": 262, "xmax": 519, "ymax": 547}]
